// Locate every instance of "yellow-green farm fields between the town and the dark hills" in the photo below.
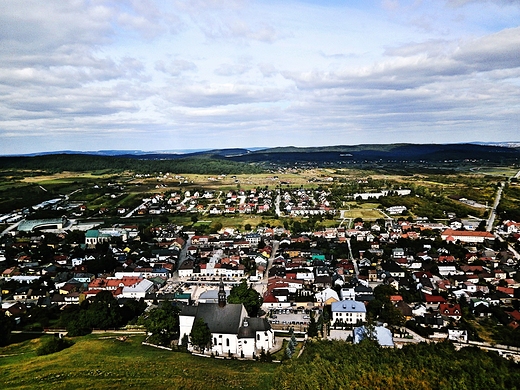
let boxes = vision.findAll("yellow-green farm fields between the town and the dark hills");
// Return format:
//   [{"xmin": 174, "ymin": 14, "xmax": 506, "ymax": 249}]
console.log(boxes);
[{"xmin": 0, "ymin": 166, "xmax": 520, "ymax": 225}]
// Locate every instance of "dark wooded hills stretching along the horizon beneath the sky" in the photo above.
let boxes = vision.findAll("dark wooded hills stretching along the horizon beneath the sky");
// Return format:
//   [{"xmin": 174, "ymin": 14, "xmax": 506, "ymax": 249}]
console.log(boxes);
[{"xmin": 4, "ymin": 143, "xmax": 520, "ymax": 174}]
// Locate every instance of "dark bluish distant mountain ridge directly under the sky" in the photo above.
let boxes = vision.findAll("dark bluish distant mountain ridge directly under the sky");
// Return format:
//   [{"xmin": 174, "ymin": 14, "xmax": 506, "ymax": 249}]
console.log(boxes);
[{"xmin": 4, "ymin": 142, "xmax": 520, "ymax": 166}]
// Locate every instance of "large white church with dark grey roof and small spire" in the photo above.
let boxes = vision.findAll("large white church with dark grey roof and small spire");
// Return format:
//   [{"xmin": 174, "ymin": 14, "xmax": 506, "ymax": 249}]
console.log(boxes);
[{"xmin": 179, "ymin": 281, "xmax": 274, "ymax": 357}]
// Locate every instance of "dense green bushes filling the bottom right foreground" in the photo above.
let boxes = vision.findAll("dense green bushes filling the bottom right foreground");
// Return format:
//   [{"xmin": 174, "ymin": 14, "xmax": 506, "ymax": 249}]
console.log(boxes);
[{"xmin": 272, "ymin": 339, "xmax": 520, "ymax": 390}]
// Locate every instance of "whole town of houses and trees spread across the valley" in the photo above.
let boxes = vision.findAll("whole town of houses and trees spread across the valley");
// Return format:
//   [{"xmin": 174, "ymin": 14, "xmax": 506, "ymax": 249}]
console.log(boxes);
[{"xmin": 0, "ymin": 165, "xmax": 520, "ymax": 366}]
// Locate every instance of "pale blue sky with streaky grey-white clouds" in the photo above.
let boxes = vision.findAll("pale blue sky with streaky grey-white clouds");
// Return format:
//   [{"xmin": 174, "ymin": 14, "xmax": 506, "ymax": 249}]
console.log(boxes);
[{"xmin": 0, "ymin": 0, "xmax": 520, "ymax": 155}]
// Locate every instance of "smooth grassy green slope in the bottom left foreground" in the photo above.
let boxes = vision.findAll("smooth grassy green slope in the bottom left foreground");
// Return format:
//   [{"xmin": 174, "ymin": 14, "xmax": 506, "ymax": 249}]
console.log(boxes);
[{"xmin": 0, "ymin": 334, "xmax": 276, "ymax": 390}]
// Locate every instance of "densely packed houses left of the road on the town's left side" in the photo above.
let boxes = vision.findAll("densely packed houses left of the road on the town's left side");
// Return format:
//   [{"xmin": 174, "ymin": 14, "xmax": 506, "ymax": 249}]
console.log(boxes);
[{"xmin": 0, "ymin": 225, "xmax": 189, "ymax": 320}]
